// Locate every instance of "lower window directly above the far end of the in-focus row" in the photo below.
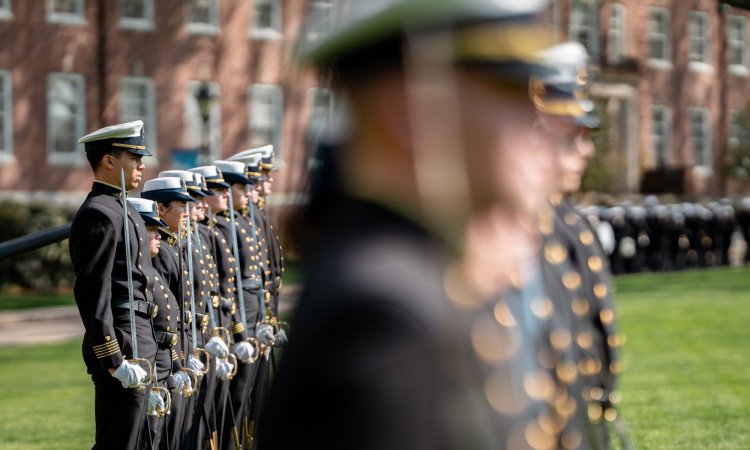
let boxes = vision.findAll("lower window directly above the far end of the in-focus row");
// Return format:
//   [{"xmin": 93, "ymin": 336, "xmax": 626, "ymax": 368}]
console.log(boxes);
[{"xmin": 250, "ymin": 84, "xmax": 284, "ymax": 158}]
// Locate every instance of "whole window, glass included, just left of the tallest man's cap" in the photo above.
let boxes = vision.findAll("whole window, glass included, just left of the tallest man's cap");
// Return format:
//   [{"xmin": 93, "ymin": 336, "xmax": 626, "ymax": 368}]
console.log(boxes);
[{"xmin": 47, "ymin": 73, "xmax": 86, "ymax": 164}]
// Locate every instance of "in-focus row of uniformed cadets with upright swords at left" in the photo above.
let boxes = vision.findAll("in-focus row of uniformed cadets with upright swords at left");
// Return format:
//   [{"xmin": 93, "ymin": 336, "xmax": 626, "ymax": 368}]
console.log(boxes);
[{"xmin": 71, "ymin": 121, "xmax": 285, "ymax": 449}]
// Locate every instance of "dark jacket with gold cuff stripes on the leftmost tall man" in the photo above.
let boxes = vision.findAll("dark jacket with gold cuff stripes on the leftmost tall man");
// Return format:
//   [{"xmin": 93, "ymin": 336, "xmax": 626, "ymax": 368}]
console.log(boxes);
[{"xmin": 70, "ymin": 181, "xmax": 156, "ymax": 373}]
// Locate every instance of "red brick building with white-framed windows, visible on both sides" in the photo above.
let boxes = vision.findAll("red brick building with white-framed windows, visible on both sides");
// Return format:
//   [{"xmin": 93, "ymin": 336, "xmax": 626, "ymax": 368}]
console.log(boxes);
[{"xmin": 0, "ymin": 0, "xmax": 750, "ymax": 201}]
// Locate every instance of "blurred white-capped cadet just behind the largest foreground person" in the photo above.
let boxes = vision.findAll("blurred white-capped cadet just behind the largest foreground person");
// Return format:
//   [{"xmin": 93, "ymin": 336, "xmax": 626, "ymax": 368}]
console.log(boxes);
[{"xmin": 532, "ymin": 42, "xmax": 627, "ymax": 448}]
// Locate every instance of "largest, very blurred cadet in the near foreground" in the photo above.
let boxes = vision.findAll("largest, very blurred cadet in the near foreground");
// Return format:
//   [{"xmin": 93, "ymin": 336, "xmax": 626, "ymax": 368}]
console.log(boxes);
[{"xmin": 259, "ymin": 0, "xmax": 608, "ymax": 450}]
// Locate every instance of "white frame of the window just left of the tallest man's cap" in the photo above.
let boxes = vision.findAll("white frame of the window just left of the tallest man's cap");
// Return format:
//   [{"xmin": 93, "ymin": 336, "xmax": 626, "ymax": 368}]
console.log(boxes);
[{"xmin": 47, "ymin": 72, "xmax": 86, "ymax": 165}]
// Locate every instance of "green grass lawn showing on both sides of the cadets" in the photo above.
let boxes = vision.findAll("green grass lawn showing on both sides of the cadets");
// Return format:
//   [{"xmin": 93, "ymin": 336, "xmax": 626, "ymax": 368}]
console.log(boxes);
[{"xmin": 0, "ymin": 269, "xmax": 750, "ymax": 450}]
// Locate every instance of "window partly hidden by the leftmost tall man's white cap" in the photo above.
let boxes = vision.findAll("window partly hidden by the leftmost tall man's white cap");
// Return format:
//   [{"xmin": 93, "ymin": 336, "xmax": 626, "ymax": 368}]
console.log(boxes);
[{"xmin": 120, "ymin": 77, "xmax": 156, "ymax": 154}]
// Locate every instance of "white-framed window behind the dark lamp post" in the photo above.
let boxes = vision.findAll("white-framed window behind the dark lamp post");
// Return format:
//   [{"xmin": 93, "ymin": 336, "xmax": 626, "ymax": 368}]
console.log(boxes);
[{"xmin": 183, "ymin": 80, "xmax": 222, "ymax": 163}]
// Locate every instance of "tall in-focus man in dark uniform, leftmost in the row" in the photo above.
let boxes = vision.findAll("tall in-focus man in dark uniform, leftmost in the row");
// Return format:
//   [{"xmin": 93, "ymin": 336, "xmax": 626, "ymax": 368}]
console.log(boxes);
[{"xmin": 70, "ymin": 120, "xmax": 157, "ymax": 449}]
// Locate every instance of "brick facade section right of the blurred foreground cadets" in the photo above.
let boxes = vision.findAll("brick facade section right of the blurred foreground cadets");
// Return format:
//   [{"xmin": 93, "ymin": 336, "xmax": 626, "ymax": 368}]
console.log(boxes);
[{"xmin": 551, "ymin": 0, "xmax": 750, "ymax": 195}]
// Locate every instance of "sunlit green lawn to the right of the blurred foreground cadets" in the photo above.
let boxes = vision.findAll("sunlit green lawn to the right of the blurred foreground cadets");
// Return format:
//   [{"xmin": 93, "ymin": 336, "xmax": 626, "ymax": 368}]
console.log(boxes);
[{"xmin": 616, "ymin": 269, "xmax": 750, "ymax": 449}]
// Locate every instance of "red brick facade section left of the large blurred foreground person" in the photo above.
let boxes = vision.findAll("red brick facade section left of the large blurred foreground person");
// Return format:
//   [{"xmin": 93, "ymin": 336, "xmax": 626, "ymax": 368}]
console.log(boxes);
[{"xmin": 0, "ymin": 0, "xmax": 335, "ymax": 203}]
